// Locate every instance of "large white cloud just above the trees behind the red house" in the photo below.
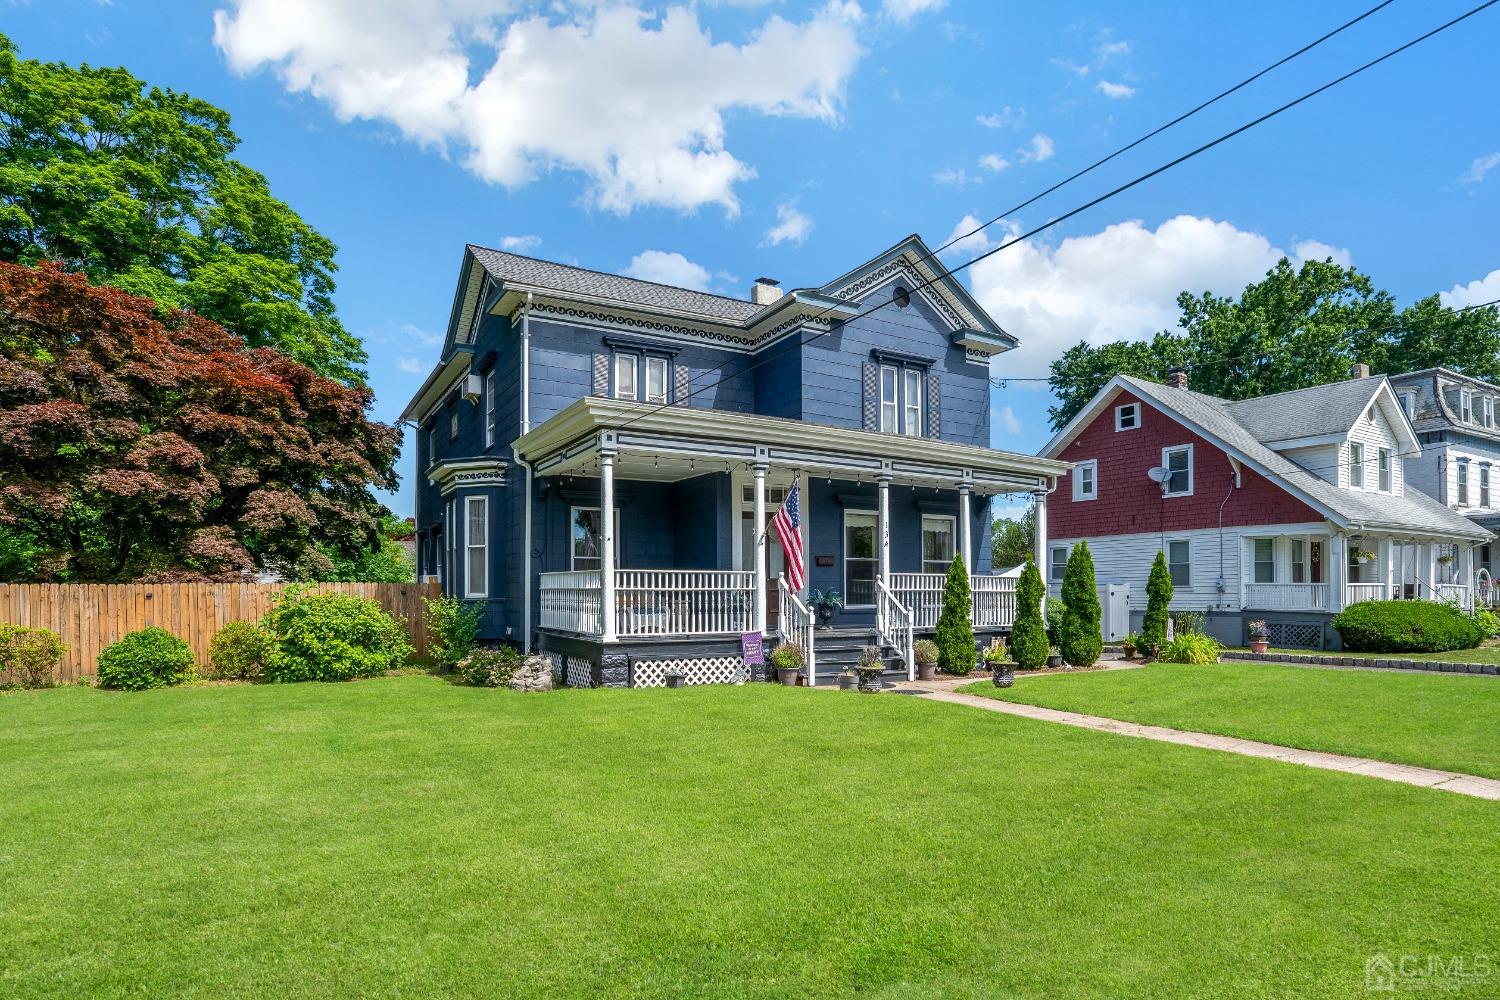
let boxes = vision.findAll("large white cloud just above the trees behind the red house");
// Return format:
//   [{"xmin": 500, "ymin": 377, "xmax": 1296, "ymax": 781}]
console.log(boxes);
[{"xmin": 956, "ymin": 216, "xmax": 1349, "ymax": 376}]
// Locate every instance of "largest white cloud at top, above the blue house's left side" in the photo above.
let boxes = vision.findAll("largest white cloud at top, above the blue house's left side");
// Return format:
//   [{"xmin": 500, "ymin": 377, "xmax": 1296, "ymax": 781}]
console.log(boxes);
[{"xmin": 215, "ymin": 0, "xmax": 863, "ymax": 213}]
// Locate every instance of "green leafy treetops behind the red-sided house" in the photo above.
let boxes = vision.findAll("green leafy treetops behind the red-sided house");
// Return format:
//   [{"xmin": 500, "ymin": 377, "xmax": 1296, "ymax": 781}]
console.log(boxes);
[{"xmin": 1049, "ymin": 258, "xmax": 1500, "ymax": 427}]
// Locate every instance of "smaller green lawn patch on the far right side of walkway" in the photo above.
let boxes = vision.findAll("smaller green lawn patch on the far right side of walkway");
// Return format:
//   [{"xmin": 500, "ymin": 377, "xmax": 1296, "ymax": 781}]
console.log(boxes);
[{"xmin": 963, "ymin": 660, "xmax": 1500, "ymax": 778}]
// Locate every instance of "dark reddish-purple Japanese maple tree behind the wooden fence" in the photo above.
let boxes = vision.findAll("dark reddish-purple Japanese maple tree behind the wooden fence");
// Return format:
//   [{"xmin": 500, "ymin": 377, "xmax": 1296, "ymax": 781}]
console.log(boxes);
[{"xmin": 0, "ymin": 262, "xmax": 401, "ymax": 582}]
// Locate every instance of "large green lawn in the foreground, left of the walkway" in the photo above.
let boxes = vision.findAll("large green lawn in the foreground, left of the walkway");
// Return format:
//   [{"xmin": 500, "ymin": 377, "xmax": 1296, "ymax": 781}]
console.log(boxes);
[{"xmin": 0, "ymin": 672, "xmax": 1500, "ymax": 999}]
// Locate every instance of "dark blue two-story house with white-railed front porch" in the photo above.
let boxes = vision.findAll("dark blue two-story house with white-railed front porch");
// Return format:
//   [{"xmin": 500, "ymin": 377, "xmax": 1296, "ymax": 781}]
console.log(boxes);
[{"xmin": 402, "ymin": 235, "xmax": 1068, "ymax": 685}]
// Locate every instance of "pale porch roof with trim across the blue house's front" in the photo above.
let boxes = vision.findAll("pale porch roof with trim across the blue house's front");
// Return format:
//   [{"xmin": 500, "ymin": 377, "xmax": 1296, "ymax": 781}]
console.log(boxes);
[{"xmin": 512, "ymin": 396, "xmax": 1071, "ymax": 493}]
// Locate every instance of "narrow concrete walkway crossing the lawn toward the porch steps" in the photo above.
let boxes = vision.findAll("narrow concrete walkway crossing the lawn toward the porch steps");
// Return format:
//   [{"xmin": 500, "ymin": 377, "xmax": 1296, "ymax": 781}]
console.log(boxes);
[{"xmin": 897, "ymin": 678, "xmax": 1500, "ymax": 801}]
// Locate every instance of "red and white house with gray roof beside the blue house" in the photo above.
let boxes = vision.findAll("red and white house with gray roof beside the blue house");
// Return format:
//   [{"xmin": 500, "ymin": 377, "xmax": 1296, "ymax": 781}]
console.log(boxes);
[{"xmin": 1041, "ymin": 372, "xmax": 1490, "ymax": 649}]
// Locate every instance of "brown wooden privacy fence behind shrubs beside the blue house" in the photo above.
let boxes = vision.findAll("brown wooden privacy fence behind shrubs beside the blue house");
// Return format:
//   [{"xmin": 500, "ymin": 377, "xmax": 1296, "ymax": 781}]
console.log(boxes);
[{"xmin": 0, "ymin": 583, "xmax": 440, "ymax": 681}]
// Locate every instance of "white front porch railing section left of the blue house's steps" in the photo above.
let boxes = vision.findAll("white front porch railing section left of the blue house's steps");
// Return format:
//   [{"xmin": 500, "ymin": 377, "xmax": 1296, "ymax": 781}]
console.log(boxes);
[{"xmin": 615, "ymin": 570, "xmax": 755, "ymax": 639}]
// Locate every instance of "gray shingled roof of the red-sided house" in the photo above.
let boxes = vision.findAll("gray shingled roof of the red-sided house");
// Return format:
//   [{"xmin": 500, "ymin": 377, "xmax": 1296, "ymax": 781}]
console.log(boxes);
[{"xmin": 1121, "ymin": 375, "xmax": 1490, "ymax": 538}]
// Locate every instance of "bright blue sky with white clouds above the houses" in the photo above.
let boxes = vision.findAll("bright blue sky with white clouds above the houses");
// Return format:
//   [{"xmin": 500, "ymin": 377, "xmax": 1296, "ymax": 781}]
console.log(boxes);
[{"xmin": 0, "ymin": 0, "xmax": 1500, "ymax": 513}]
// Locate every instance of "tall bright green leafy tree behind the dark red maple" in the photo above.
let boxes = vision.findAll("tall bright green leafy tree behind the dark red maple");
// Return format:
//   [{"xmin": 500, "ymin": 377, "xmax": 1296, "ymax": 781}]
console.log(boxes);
[{"xmin": 0, "ymin": 34, "xmax": 366, "ymax": 385}]
